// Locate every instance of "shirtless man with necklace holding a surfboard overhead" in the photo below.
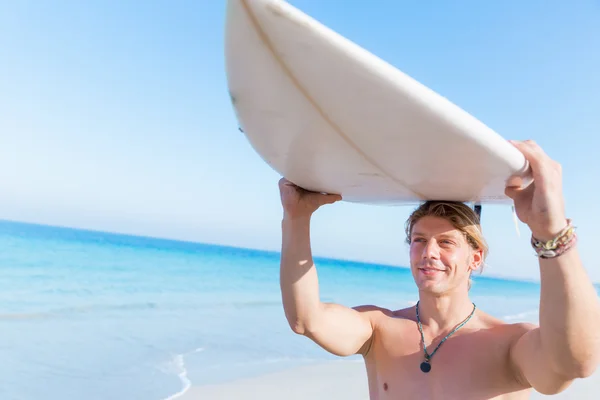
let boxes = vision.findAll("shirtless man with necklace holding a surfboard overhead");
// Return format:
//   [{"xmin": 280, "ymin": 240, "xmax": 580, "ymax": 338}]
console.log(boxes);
[{"xmin": 280, "ymin": 141, "xmax": 600, "ymax": 400}]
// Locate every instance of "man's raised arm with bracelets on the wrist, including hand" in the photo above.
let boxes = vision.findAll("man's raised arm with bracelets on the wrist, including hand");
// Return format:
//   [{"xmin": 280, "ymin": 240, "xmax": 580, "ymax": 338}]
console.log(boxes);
[{"xmin": 507, "ymin": 141, "xmax": 600, "ymax": 394}]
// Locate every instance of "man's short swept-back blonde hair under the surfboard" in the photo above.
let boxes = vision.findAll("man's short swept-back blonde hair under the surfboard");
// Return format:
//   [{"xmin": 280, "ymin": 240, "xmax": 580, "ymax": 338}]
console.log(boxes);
[{"xmin": 405, "ymin": 201, "xmax": 489, "ymax": 282}]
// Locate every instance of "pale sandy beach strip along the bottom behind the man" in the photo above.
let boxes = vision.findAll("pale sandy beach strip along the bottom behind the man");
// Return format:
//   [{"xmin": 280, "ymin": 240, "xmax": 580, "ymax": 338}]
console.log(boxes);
[{"xmin": 179, "ymin": 361, "xmax": 600, "ymax": 400}]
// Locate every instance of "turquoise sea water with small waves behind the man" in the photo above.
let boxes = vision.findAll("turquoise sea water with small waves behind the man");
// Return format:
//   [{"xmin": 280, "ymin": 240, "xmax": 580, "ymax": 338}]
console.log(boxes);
[{"xmin": 0, "ymin": 222, "xmax": 539, "ymax": 400}]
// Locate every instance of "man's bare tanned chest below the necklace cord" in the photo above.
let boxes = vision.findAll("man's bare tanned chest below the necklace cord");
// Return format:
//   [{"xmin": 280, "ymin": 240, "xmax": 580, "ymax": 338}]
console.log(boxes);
[{"xmin": 366, "ymin": 321, "xmax": 527, "ymax": 400}]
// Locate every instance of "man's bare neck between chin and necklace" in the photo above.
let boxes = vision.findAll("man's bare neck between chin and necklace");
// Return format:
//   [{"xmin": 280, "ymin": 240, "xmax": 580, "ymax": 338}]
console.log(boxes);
[{"xmin": 419, "ymin": 291, "xmax": 473, "ymax": 332}]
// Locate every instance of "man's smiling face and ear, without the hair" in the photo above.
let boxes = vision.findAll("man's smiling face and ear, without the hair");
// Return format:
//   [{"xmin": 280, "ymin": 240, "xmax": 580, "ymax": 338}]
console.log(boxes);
[{"xmin": 410, "ymin": 217, "xmax": 482, "ymax": 294}]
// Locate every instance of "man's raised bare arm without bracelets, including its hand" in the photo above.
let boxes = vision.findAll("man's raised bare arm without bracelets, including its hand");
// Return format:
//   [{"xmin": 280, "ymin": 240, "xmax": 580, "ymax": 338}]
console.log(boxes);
[{"xmin": 279, "ymin": 179, "xmax": 375, "ymax": 356}]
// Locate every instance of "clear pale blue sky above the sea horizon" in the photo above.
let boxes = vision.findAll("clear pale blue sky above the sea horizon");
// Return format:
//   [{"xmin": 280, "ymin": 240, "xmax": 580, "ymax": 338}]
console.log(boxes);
[{"xmin": 0, "ymin": 0, "xmax": 600, "ymax": 281}]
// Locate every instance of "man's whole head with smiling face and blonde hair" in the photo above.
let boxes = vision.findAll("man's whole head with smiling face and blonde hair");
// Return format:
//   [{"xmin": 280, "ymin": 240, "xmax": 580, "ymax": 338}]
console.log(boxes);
[{"xmin": 407, "ymin": 202, "xmax": 487, "ymax": 295}]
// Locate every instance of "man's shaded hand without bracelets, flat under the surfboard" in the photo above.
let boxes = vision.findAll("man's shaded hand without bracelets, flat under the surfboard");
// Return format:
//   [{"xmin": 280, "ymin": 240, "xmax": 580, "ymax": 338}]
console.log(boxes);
[{"xmin": 279, "ymin": 178, "xmax": 342, "ymax": 219}]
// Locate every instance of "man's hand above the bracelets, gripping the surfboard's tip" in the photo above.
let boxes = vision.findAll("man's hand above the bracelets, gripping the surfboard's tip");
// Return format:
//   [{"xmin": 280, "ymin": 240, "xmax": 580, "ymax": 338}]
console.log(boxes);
[{"xmin": 505, "ymin": 140, "xmax": 567, "ymax": 241}]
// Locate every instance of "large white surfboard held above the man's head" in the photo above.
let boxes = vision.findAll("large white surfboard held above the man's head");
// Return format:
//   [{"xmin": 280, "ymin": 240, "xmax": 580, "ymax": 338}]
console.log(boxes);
[{"xmin": 225, "ymin": 0, "xmax": 530, "ymax": 205}]
